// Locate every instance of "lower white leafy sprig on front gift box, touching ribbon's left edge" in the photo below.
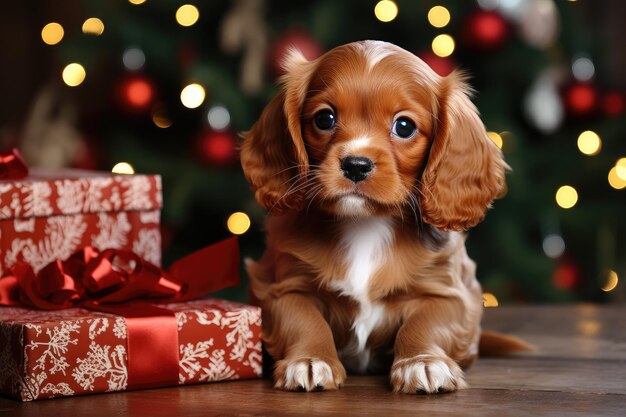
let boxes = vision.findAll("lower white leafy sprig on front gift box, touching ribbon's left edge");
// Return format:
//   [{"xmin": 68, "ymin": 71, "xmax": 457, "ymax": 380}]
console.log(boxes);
[{"xmin": 72, "ymin": 342, "xmax": 128, "ymax": 391}]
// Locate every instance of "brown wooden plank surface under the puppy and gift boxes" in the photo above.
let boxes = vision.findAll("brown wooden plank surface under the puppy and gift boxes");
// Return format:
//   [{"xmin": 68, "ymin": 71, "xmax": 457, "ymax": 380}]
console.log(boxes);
[{"xmin": 0, "ymin": 306, "xmax": 626, "ymax": 417}]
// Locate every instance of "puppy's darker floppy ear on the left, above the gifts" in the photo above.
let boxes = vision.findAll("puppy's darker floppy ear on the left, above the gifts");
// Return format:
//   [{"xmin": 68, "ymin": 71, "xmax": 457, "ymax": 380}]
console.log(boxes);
[{"xmin": 241, "ymin": 50, "xmax": 315, "ymax": 214}]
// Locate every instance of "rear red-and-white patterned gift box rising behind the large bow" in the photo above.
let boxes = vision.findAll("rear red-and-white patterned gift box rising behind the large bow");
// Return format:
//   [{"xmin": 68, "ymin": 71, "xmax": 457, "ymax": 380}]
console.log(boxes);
[{"xmin": 0, "ymin": 169, "xmax": 161, "ymax": 276}]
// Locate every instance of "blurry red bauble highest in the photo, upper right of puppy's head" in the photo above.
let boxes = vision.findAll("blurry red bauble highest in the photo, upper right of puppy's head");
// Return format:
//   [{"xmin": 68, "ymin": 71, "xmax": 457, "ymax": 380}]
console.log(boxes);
[{"xmin": 463, "ymin": 11, "xmax": 510, "ymax": 52}]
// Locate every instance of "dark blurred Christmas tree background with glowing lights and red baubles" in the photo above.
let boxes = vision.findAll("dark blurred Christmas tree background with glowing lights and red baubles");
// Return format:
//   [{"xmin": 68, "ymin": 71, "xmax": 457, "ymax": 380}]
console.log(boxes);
[{"xmin": 0, "ymin": 0, "xmax": 626, "ymax": 305}]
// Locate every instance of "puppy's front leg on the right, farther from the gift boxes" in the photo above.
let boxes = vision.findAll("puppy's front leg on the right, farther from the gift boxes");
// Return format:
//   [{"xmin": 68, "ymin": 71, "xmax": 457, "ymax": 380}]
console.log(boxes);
[{"xmin": 391, "ymin": 299, "xmax": 472, "ymax": 394}]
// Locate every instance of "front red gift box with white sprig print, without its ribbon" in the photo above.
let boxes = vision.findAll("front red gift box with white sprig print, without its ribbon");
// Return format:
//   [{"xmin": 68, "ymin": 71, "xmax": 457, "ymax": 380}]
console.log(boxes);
[{"xmin": 0, "ymin": 298, "xmax": 261, "ymax": 401}]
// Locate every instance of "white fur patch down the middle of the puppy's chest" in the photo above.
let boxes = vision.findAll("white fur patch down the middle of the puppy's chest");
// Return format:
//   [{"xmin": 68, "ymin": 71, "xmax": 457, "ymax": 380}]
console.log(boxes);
[{"xmin": 332, "ymin": 218, "xmax": 393, "ymax": 371}]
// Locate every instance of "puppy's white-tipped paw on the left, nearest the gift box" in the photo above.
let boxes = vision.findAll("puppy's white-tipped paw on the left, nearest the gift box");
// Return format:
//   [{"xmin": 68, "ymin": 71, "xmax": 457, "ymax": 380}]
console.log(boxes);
[{"xmin": 274, "ymin": 358, "xmax": 346, "ymax": 391}]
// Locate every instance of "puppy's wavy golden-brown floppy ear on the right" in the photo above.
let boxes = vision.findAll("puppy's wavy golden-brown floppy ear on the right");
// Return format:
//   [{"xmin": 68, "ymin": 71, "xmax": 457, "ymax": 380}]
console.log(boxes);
[{"xmin": 420, "ymin": 72, "xmax": 507, "ymax": 230}]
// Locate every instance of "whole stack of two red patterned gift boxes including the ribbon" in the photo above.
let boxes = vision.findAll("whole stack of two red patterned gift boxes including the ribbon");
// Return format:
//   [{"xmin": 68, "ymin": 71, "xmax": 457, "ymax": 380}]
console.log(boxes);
[{"xmin": 0, "ymin": 165, "xmax": 261, "ymax": 401}]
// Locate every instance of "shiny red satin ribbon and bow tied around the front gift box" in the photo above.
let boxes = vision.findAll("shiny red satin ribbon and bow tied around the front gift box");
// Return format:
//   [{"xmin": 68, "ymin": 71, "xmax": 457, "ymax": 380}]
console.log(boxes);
[{"xmin": 0, "ymin": 237, "xmax": 239, "ymax": 389}]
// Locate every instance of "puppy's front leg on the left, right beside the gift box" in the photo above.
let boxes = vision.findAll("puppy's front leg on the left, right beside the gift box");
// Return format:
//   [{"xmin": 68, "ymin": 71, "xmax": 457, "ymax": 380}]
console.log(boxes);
[{"xmin": 264, "ymin": 294, "xmax": 346, "ymax": 391}]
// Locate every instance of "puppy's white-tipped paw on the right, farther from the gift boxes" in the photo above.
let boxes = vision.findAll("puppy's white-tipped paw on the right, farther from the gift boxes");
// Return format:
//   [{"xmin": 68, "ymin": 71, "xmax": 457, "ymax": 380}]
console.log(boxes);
[{"xmin": 391, "ymin": 355, "xmax": 467, "ymax": 394}]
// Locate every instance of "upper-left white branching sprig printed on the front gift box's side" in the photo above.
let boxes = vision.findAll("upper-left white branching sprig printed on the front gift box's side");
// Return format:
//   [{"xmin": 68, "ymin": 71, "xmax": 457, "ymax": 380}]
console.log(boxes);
[{"xmin": 25, "ymin": 321, "xmax": 80, "ymax": 375}]
